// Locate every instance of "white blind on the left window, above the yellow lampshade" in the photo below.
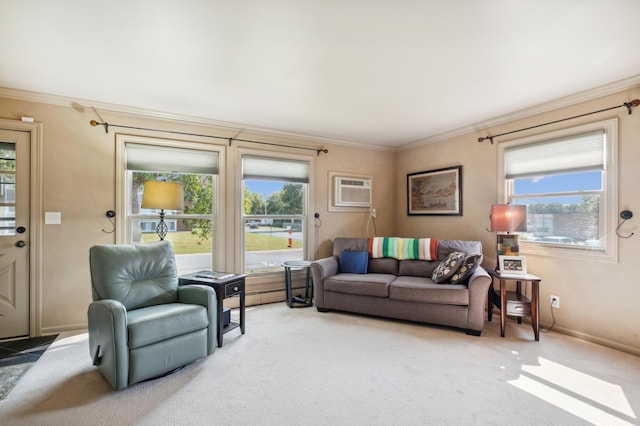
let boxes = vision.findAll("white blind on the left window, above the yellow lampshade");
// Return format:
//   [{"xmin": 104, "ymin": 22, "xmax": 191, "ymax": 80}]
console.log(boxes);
[{"xmin": 126, "ymin": 143, "xmax": 219, "ymax": 175}]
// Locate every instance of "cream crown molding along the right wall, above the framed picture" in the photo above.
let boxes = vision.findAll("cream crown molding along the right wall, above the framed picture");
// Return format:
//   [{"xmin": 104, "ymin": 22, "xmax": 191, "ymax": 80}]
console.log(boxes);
[{"xmin": 398, "ymin": 75, "xmax": 640, "ymax": 151}]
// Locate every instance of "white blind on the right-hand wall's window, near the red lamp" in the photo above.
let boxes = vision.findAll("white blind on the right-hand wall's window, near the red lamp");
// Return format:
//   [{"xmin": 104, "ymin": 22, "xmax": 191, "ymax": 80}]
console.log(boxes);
[{"xmin": 504, "ymin": 130, "xmax": 606, "ymax": 179}]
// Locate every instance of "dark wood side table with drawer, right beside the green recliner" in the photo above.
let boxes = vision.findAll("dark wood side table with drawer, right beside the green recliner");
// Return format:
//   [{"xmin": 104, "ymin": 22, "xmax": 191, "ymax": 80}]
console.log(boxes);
[{"xmin": 179, "ymin": 272, "xmax": 246, "ymax": 347}]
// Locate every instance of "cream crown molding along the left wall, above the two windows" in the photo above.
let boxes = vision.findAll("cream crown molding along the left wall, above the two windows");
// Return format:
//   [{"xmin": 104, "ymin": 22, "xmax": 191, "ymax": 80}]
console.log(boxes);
[{"xmin": 0, "ymin": 87, "xmax": 395, "ymax": 151}]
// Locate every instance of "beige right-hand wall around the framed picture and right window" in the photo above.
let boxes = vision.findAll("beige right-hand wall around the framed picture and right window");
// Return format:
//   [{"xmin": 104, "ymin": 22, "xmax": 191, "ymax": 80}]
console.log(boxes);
[{"xmin": 396, "ymin": 88, "xmax": 640, "ymax": 354}]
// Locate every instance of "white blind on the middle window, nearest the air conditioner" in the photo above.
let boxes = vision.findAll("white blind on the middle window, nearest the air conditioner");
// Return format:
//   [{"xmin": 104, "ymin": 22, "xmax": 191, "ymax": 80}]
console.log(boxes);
[{"xmin": 242, "ymin": 155, "xmax": 309, "ymax": 183}]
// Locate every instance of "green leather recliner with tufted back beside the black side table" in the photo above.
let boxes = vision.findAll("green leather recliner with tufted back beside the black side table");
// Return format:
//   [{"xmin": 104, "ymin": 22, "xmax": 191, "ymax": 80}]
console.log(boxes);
[{"xmin": 87, "ymin": 241, "xmax": 217, "ymax": 390}]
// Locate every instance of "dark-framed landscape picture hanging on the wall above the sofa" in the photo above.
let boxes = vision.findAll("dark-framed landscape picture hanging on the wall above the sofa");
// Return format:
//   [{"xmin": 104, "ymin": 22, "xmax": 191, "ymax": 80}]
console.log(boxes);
[{"xmin": 407, "ymin": 166, "xmax": 462, "ymax": 216}]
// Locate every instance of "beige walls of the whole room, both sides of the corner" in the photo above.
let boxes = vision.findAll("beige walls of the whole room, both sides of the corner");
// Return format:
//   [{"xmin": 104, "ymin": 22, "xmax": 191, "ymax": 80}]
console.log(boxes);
[{"xmin": 0, "ymin": 84, "xmax": 640, "ymax": 354}]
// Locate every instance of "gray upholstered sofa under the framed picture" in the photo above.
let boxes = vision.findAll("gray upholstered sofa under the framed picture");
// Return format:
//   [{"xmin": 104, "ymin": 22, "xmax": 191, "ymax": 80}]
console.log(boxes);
[{"xmin": 311, "ymin": 238, "xmax": 491, "ymax": 336}]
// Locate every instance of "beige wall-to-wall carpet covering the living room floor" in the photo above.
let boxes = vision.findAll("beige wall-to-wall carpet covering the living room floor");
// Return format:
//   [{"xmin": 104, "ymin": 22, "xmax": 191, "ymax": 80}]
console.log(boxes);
[{"xmin": 0, "ymin": 303, "xmax": 640, "ymax": 426}]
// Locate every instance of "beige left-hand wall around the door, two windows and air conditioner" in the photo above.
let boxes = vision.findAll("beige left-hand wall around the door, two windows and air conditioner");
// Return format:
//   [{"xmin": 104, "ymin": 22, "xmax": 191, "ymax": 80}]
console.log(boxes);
[{"xmin": 0, "ymin": 93, "xmax": 395, "ymax": 333}]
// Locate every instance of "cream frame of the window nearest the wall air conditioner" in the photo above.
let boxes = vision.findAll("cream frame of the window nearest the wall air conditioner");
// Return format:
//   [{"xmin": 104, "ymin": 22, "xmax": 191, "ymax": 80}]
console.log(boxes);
[{"xmin": 235, "ymin": 149, "xmax": 315, "ymax": 276}]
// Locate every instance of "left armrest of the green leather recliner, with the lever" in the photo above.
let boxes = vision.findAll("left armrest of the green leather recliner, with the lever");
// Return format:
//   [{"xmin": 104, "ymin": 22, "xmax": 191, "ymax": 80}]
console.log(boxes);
[{"xmin": 87, "ymin": 299, "xmax": 129, "ymax": 390}]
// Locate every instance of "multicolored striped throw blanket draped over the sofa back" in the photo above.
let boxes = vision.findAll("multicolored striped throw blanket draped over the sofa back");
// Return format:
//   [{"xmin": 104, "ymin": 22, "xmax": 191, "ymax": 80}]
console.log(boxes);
[{"xmin": 369, "ymin": 237, "xmax": 438, "ymax": 260}]
